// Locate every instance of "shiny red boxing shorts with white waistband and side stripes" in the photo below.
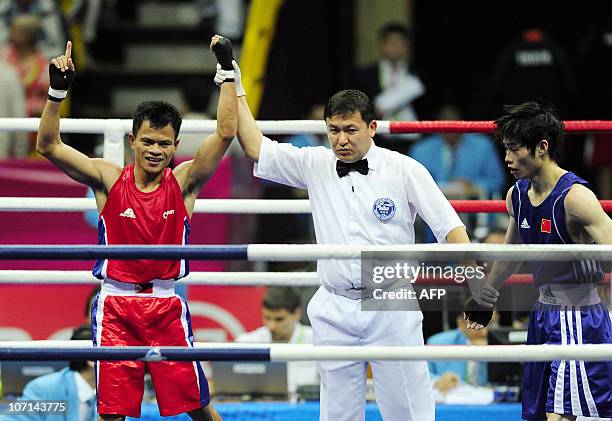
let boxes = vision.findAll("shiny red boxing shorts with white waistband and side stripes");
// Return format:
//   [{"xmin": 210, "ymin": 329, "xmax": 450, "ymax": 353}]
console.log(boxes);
[{"xmin": 91, "ymin": 279, "xmax": 210, "ymax": 418}]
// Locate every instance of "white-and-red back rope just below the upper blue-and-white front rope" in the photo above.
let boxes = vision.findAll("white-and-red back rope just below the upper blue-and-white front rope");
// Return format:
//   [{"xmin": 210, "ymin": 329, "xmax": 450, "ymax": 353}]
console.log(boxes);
[{"xmin": 0, "ymin": 270, "xmax": 610, "ymax": 287}]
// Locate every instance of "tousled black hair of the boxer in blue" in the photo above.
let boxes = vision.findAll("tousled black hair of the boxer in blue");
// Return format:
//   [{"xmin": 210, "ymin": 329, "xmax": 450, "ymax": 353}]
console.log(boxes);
[{"xmin": 495, "ymin": 101, "xmax": 565, "ymax": 162}]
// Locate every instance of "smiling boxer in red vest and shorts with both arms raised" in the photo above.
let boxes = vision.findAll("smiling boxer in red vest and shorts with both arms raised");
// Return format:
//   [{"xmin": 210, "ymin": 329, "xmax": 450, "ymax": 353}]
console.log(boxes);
[{"xmin": 36, "ymin": 36, "xmax": 237, "ymax": 420}]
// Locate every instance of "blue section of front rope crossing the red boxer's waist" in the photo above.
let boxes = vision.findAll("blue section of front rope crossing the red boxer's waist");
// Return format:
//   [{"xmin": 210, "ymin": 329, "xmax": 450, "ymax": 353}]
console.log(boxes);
[{"xmin": 0, "ymin": 245, "xmax": 248, "ymax": 260}]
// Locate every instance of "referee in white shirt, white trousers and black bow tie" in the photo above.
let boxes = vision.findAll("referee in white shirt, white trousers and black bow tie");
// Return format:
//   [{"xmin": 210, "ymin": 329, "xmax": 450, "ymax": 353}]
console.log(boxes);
[{"xmin": 215, "ymin": 52, "xmax": 469, "ymax": 421}]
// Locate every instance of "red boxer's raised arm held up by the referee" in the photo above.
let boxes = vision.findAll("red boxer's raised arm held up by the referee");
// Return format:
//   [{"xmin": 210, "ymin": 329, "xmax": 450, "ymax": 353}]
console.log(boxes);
[{"xmin": 174, "ymin": 35, "xmax": 238, "ymax": 205}]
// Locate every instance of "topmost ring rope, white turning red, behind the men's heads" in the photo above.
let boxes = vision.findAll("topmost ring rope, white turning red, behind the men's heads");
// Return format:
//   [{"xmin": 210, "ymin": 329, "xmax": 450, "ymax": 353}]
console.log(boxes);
[{"xmin": 0, "ymin": 118, "xmax": 612, "ymax": 134}]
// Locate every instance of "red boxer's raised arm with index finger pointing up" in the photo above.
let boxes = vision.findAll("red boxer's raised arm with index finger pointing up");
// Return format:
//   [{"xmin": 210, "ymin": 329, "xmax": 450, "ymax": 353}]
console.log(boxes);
[{"xmin": 36, "ymin": 41, "xmax": 121, "ymax": 191}]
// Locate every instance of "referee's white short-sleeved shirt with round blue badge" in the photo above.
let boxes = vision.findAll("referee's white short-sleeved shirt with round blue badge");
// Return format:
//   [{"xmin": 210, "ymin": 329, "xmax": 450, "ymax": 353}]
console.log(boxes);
[{"xmin": 253, "ymin": 137, "xmax": 464, "ymax": 289}]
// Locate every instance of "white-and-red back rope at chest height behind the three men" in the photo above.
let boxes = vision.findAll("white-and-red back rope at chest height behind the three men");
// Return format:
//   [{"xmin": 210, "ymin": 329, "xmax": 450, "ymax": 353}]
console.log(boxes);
[{"xmin": 0, "ymin": 197, "xmax": 612, "ymax": 214}]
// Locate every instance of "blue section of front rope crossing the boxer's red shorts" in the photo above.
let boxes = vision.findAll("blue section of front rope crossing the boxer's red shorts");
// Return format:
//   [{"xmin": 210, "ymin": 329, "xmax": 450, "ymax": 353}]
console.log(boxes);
[{"xmin": 0, "ymin": 346, "xmax": 270, "ymax": 361}]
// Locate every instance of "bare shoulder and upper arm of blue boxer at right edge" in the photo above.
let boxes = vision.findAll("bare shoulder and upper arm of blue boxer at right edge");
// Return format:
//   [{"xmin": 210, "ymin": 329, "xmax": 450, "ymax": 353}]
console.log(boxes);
[{"xmin": 565, "ymin": 184, "xmax": 612, "ymax": 244}]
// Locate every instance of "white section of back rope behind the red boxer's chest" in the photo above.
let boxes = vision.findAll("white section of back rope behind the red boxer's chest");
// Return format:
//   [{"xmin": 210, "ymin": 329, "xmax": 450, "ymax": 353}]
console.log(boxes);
[{"xmin": 0, "ymin": 197, "xmax": 310, "ymax": 214}]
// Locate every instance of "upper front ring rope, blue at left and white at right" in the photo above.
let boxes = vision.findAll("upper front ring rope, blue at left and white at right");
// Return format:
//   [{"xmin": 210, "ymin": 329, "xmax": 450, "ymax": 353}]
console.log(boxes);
[{"xmin": 0, "ymin": 244, "xmax": 612, "ymax": 262}]
